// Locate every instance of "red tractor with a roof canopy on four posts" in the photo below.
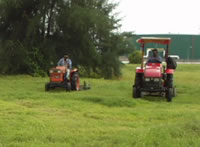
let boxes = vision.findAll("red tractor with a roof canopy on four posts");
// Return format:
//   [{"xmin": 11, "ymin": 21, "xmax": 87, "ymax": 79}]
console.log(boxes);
[{"xmin": 133, "ymin": 37, "xmax": 176, "ymax": 102}]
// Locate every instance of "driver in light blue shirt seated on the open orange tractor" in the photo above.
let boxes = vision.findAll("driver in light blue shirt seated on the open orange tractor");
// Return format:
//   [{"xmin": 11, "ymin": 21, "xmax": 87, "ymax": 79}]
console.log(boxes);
[{"xmin": 58, "ymin": 55, "xmax": 72, "ymax": 80}]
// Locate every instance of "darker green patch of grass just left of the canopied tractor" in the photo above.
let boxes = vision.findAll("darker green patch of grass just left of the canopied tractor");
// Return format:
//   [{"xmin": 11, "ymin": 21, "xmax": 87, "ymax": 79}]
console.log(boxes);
[{"xmin": 79, "ymin": 97, "xmax": 136, "ymax": 107}]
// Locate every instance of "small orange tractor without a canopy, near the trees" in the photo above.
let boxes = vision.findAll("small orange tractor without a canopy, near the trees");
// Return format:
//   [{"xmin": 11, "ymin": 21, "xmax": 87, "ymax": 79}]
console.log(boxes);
[{"xmin": 45, "ymin": 66, "xmax": 80, "ymax": 91}]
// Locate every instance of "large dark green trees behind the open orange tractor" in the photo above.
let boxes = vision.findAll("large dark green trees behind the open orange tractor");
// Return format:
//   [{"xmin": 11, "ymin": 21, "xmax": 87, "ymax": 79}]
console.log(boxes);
[{"xmin": 0, "ymin": 0, "xmax": 134, "ymax": 78}]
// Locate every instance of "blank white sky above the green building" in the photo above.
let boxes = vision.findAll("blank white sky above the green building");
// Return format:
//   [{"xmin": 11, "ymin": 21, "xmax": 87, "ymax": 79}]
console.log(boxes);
[{"xmin": 112, "ymin": 0, "xmax": 200, "ymax": 34}]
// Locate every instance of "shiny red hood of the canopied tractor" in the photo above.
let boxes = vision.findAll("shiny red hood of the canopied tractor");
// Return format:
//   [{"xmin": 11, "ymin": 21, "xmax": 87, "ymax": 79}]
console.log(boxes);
[{"xmin": 144, "ymin": 64, "xmax": 162, "ymax": 78}]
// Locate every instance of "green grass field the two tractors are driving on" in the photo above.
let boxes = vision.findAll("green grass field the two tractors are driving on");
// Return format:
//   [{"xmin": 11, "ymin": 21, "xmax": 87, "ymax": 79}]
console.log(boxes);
[{"xmin": 0, "ymin": 65, "xmax": 200, "ymax": 147}]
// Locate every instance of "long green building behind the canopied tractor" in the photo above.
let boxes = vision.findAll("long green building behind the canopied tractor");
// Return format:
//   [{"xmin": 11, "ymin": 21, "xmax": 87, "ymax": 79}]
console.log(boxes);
[{"xmin": 134, "ymin": 34, "xmax": 200, "ymax": 60}]
